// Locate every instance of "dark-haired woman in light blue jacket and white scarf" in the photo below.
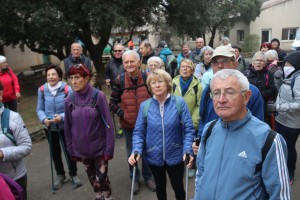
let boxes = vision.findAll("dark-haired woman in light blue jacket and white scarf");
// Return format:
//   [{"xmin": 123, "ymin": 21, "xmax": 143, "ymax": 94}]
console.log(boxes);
[{"xmin": 36, "ymin": 65, "xmax": 82, "ymax": 189}]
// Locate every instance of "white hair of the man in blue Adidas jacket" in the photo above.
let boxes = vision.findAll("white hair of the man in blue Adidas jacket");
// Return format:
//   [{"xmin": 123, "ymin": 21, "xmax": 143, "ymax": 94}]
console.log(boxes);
[{"xmin": 210, "ymin": 69, "xmax": 249, "ymax": 91}]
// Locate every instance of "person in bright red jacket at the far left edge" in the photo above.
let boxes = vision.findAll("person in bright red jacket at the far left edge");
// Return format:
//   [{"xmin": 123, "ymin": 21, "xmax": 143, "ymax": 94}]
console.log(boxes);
[{"xmin": 0, "ymin": 55, "xmax": 21, "ymax": 112}]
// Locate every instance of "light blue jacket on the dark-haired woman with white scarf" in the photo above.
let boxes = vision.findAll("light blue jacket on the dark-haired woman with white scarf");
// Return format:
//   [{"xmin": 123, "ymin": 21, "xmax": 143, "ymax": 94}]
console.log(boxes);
[{"xmin": 36, "ymin": 82, "xmax": 72, "ymax": 130}]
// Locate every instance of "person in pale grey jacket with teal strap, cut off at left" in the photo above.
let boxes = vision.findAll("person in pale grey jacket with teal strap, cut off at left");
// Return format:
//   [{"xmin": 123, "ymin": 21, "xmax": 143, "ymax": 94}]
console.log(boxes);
[{"xmin": 0, "ymin": 83, "xmax": 32, "ymax": 199}]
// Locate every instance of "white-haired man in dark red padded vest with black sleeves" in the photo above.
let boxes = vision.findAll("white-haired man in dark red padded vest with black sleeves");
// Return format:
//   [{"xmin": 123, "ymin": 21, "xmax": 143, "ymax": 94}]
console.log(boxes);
[{"xmin": 109, "ymin": 50, "xmax": 156, "ymax": 194}]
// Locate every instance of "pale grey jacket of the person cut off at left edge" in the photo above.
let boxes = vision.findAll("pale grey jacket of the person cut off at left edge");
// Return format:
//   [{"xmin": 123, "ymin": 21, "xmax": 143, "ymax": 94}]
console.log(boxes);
[{"xmin": 0, "ymin": 106, "xmax": 32, "ymax": 180}]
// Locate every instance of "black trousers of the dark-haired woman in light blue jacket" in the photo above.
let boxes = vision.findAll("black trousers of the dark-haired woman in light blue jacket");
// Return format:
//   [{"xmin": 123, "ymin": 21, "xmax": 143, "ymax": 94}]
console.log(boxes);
[{"xmin": 45, "ymin": 129, "xmax": 77, "ymax": 177}]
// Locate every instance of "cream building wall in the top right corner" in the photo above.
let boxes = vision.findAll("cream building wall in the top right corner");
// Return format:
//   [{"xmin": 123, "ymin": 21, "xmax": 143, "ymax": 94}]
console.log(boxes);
[{"xmin": 250, "ymin": 0, "xmax": 300, "ymax": 50}]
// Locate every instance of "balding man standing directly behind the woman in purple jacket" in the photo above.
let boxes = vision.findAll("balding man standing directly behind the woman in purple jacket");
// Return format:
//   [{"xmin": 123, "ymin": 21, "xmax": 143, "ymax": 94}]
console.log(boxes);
[{"xmin": 60, "ymin": 42, "xmax": 97, "ymax": 87}]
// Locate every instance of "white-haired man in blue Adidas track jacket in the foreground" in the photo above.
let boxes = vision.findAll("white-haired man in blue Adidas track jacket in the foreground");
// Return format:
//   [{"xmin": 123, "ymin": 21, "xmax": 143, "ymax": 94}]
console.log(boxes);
[{"xmin": 194, "ymin": 69, "xmax": 290, "ymax": 200}]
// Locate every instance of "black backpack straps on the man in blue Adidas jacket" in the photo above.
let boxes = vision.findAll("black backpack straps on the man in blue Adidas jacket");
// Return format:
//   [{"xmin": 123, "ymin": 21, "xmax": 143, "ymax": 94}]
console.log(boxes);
[{"xmin": 203, "ymin": 119, "xmax": 276, "ymax": 174}]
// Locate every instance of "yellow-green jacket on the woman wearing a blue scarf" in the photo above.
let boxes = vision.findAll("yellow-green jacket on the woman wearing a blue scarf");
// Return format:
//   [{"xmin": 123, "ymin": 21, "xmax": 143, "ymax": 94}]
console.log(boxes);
[{"xmin": 173, "ymin": 76, "xmax": 202, "ymax": 130}]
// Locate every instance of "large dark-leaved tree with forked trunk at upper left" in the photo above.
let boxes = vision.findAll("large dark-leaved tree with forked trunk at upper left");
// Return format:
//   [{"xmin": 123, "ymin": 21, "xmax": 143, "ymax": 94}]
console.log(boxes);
[{"xmin": 0, "ymin": 0, "xmax": 160, "ymax": 74}]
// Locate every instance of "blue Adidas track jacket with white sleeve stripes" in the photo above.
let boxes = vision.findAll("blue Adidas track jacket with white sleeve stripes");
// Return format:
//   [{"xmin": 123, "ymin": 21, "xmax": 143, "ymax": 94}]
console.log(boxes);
[{"xmin": 194, "ymin": 110, "xmax": 291, "ymax": 200}]
